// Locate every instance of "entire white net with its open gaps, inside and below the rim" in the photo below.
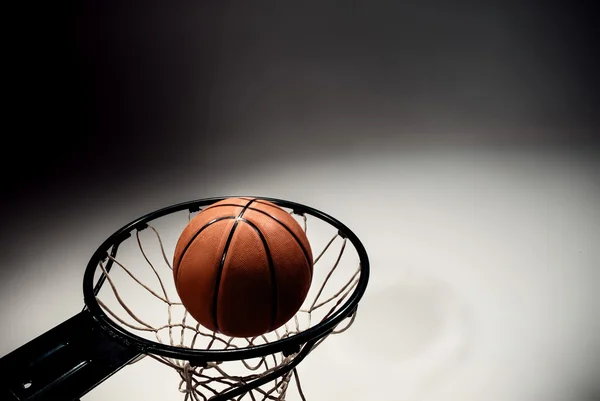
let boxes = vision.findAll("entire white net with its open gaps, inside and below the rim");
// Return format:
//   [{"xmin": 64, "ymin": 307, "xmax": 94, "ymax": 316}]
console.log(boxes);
[{"xmin": 96, "ymin": 205, "xmax": 361, "ymax": 401}]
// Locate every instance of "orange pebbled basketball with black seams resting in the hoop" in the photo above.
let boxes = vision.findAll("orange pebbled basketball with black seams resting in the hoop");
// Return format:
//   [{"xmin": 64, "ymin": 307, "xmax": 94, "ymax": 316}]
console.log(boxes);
[{"xmin": 173, "ymin": 198, "xmax": 313, "ymax": 337}]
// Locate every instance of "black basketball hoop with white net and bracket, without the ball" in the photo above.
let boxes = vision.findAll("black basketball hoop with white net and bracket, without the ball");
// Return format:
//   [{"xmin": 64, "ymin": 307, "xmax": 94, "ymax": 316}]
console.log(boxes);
[{"xmin": 0, "ymin": 197, "xmax": 369, "ymax": 401}]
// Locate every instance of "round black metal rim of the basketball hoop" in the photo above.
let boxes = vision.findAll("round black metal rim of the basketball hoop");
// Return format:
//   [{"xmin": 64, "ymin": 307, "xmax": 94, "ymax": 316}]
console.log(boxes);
[{"xmin": 83, "ymin": 195, "xmax": 370, "ymax": 363}]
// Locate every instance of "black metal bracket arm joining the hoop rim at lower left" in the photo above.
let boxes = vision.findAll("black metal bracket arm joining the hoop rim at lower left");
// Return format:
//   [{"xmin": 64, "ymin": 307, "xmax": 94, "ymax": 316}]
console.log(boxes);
[{"xmin": 0, "ymin": 310, "xmax": 140, "ymax": 401}]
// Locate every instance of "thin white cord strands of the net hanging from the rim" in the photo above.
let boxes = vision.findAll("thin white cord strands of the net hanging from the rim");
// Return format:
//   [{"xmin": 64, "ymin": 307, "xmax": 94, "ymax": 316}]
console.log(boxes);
[{"xmin": 97, "ymin": 212, "xmax": 361, "ymax": 401}]
